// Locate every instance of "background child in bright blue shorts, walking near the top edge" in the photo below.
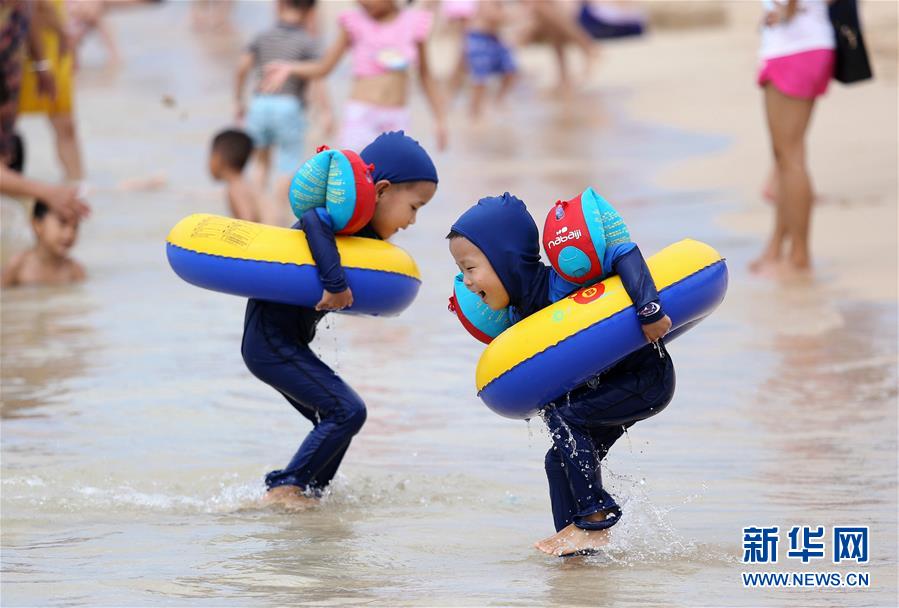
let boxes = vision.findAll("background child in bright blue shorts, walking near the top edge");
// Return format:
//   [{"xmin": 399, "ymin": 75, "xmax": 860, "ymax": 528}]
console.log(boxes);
[{"xmin": 465, "ymin": 0, "xmax": 518, "ymax": 119}]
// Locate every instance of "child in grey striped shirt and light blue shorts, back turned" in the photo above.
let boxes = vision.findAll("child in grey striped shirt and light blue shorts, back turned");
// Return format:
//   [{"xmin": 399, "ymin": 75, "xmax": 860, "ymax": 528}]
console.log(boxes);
[{"xmin": 235, "ymin": 0, "xmax": 332, "ymax": 224}]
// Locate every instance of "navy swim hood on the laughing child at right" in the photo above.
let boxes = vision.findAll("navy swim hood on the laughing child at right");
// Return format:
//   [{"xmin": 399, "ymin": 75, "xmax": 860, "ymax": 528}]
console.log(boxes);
[{"xmin": 452, "ymin": 192, "xmax": 549, "ymax": 316}]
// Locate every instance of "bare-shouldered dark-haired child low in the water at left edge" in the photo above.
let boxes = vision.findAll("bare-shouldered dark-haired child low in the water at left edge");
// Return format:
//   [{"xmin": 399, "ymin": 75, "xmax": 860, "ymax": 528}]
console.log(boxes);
[{"xmin": 0, "ymin": 200, "xmax": 86, "ymax": 287}]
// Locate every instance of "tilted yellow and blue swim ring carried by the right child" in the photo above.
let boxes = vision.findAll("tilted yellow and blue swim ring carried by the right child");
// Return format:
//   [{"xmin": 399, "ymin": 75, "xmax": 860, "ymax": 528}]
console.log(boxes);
[{"xmin": 476, "ymin": 239, "xmax": 727, "ymax": 419}]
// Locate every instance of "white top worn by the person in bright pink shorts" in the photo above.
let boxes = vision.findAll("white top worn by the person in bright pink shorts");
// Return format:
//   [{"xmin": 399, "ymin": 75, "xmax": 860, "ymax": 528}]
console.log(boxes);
[{"xmin": 759, "ymin": 0, "xmax": 836, "ymax": 59}]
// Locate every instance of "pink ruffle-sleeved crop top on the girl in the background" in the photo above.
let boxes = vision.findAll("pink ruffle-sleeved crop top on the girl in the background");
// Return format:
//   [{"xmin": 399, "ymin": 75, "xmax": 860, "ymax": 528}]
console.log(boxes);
[{"xmin": 338, "ymin": 8, "xmax": 433, "ymax": 77}]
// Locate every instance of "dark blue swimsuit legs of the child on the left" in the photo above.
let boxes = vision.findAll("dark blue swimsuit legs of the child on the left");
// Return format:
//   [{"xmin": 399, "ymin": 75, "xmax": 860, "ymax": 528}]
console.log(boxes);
[{"xmin": 241, "ymin": 303, "xmax": 366, "ymax": 494}]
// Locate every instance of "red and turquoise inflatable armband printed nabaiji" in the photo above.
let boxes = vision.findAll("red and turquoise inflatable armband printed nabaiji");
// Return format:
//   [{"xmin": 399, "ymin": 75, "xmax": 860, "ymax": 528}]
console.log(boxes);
[{"xmin": 543, "ymin": 188, "xmax": 631, "ymax": 285}]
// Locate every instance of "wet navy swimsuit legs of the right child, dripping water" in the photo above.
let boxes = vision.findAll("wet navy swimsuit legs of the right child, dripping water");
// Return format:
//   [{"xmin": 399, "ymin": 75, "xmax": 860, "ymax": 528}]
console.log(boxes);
[{"xmin": 542, "ymin": 345, "xmax": 674, "ymax": 530}]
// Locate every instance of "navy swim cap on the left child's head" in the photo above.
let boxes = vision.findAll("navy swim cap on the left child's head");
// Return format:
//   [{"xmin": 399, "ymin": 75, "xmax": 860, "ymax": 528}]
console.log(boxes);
[{"xmin": 359, "ymin": 131, "xmax": 437, "ymax": 184}]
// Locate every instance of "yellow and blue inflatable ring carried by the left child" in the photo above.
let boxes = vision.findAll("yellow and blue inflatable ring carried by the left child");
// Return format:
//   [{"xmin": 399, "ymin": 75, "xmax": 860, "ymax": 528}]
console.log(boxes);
[{"xmin": 166, "ymin": 213, "xmax": 421, "ymax": 316}]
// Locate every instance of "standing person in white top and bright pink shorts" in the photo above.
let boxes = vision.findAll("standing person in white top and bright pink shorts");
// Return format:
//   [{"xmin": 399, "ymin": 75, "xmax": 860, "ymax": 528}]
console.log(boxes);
[{"xmin": 750, "ymin": 0, "xmax": 836, "ymax": 274}]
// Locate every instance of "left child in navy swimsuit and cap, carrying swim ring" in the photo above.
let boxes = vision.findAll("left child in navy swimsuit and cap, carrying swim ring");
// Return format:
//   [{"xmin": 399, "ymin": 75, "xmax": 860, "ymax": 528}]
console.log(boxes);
[{"xmin": 241, "ymin": 131, "xmax": 437, "ymax": 508}]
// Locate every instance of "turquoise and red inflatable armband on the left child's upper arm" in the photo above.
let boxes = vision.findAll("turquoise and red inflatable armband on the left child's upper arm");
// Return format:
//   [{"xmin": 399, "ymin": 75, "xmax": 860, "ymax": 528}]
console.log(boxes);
[{"xmin": 288, "ymin": 146, "xmax": 375, "ymax": 234}]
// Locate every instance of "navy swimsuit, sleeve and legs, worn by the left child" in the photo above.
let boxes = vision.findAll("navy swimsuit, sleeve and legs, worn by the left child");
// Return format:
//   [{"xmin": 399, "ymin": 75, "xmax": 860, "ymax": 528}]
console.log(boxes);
[{"xmin": 241, "ymin": 209, "xmax": 379, "ymax": 493}]
